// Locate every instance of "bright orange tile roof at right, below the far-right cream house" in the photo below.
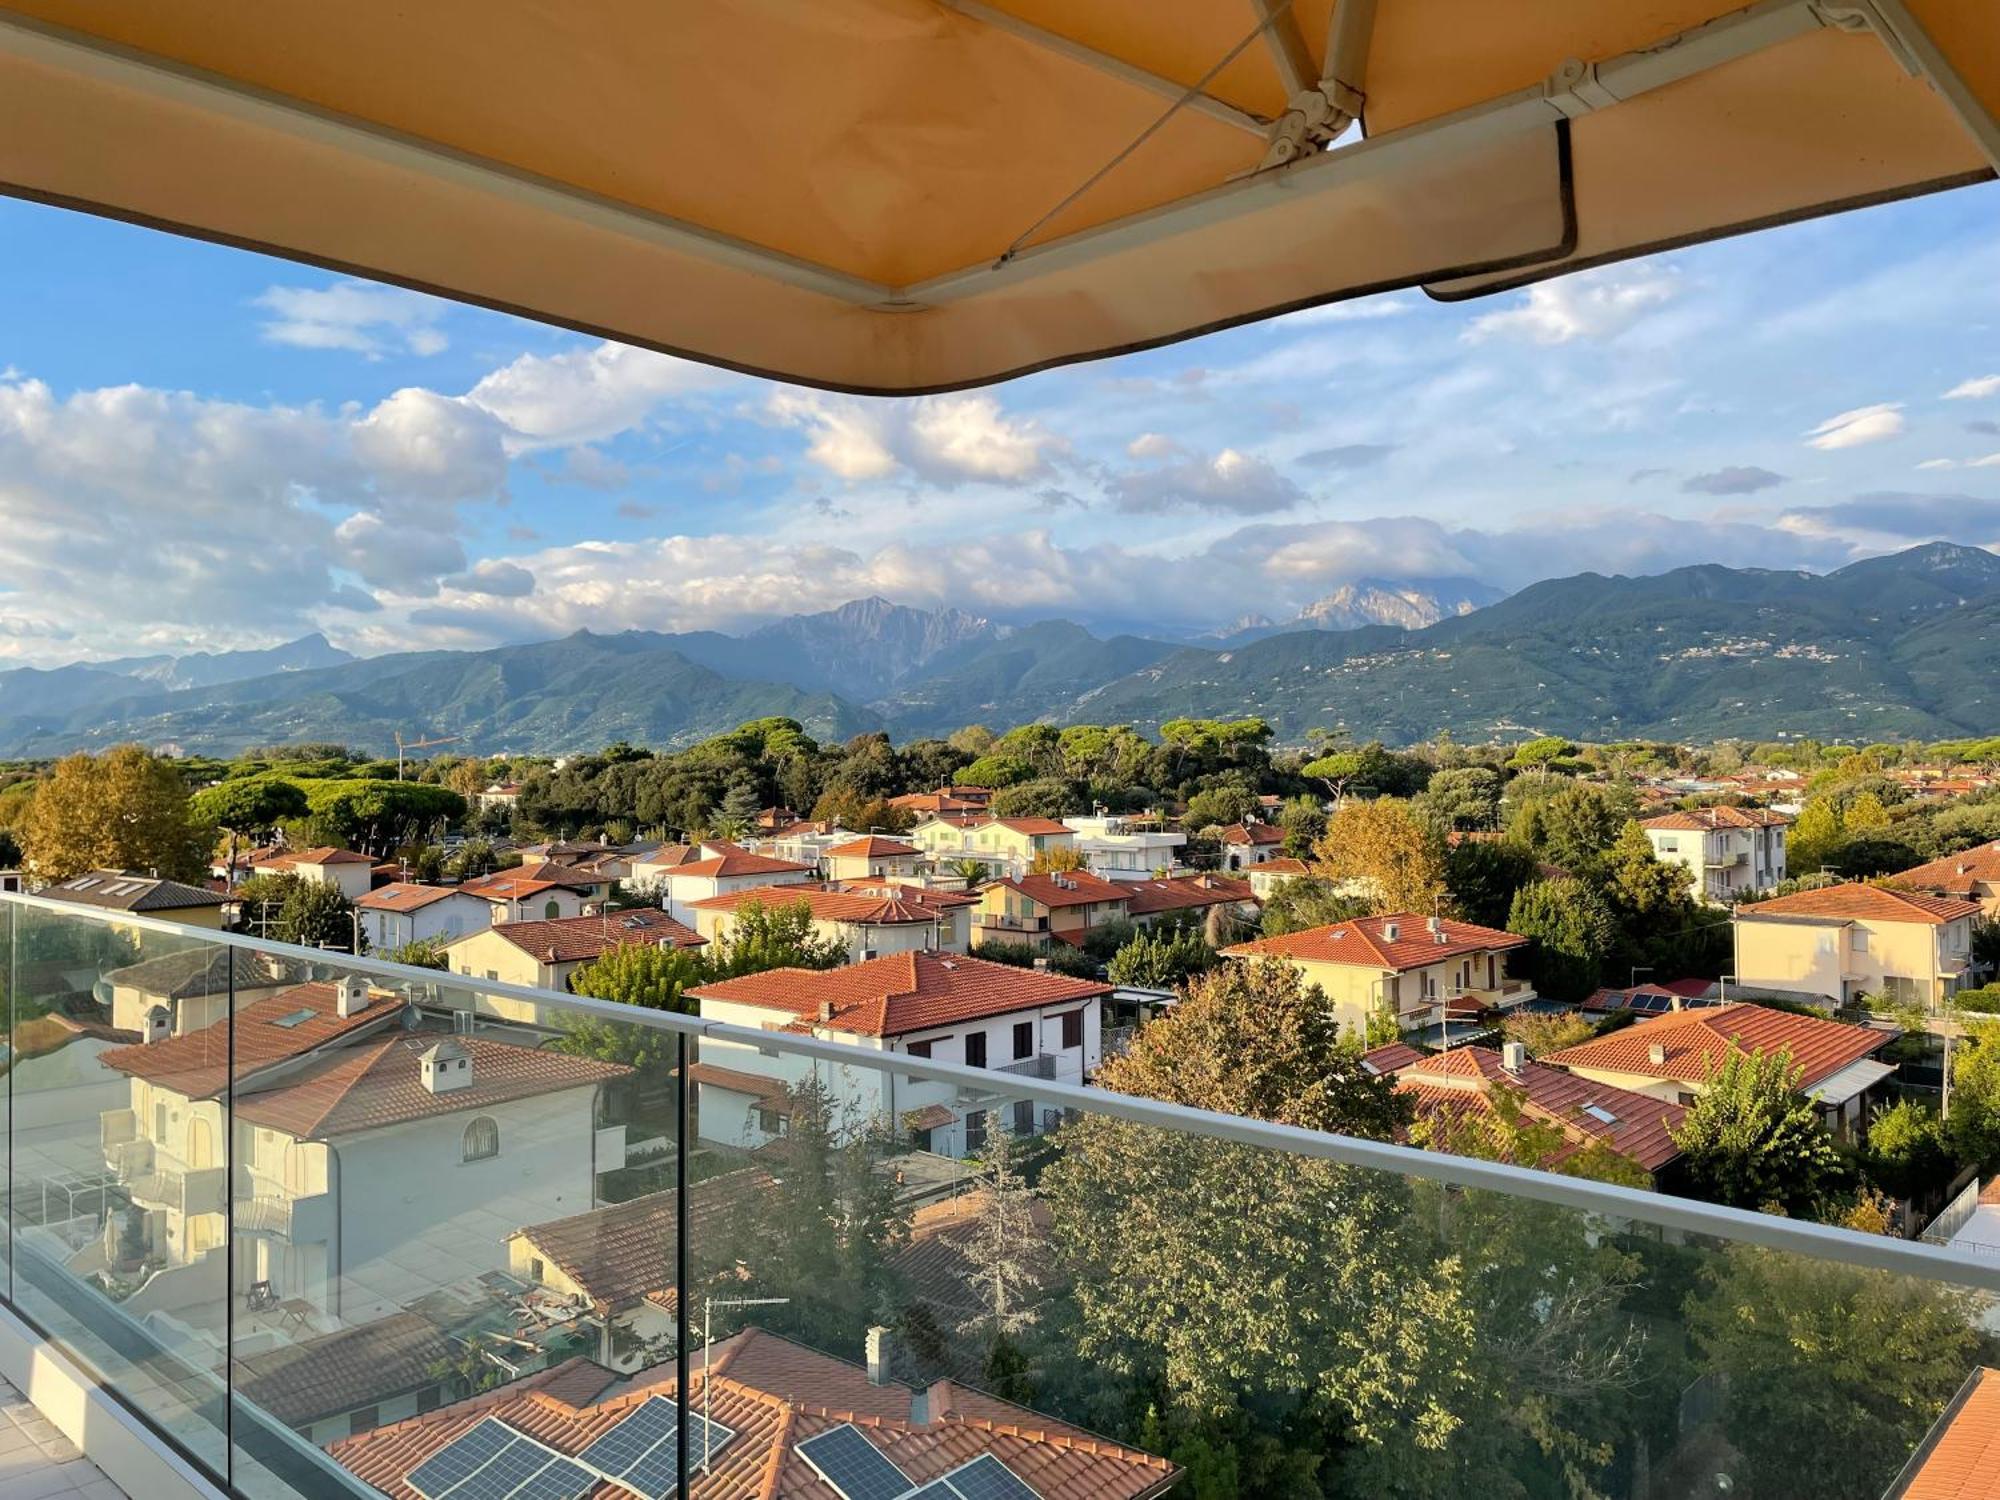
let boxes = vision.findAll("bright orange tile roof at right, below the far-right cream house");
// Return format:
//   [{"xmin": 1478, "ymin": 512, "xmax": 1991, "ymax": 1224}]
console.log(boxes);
[{"xmin": 1542, "ymin": 1002, "xmax": 1894, "ymax": 1088}]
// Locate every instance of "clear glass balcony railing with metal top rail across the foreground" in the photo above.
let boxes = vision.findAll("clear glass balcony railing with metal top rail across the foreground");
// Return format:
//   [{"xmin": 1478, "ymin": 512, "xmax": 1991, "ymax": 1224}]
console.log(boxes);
[{"xmin": 0, "ymin": 896, "xmax": 2000, "ymax": 1500}]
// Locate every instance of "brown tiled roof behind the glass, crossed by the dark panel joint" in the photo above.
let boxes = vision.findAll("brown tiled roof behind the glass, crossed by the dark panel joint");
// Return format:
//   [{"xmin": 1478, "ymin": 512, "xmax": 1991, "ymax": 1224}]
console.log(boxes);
[{"xmin": 508, "ymin": 1166, "xmax": 776, "ymax": 1312}]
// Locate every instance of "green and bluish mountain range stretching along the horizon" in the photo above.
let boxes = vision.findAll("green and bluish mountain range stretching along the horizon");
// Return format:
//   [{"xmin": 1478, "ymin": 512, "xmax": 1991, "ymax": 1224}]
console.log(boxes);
[{"xmin": 11, "ymin": 544, "xmax": 2000, "ymax": 756}]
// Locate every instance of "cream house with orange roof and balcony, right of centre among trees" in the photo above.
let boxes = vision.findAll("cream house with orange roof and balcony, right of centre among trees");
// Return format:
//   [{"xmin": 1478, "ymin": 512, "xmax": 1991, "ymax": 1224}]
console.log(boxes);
[{"xmin": 1222, "ymin": 912, "xmax": 1534, "ymax": 1036}]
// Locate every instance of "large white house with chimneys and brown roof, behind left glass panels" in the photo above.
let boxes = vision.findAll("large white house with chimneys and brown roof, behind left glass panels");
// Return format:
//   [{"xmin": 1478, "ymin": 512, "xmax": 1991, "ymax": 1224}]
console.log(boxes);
[{"xmin": 100, "ymin": 976, "xmax": 630, "ymax": 1318}]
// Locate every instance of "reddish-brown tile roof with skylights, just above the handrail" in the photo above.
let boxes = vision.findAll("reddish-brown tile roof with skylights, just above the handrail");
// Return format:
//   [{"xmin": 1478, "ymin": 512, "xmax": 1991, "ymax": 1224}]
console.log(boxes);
[{"xmin": 1396, "ymin": 1046, "xmax": 1688, "ymax": 1172}]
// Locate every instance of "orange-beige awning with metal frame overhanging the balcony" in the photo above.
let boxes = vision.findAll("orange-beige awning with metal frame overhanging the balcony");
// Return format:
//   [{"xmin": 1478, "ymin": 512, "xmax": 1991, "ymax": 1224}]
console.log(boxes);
[{"xmin": 0, "ymin": 0, "xmax": 2000, "ymax": 394}]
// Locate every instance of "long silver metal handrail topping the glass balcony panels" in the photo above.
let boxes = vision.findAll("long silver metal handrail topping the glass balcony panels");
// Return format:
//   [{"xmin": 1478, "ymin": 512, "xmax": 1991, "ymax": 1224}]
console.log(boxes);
[{"xmin": 11, "ymin": 892, "xmax": 2000, "ymax": 1294}]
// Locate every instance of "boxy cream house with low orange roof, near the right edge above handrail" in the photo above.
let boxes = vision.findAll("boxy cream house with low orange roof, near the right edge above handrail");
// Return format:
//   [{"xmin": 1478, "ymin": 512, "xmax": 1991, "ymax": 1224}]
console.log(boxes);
[{"xmin": 1732, "ymin": 884, "xmax": 1980, "ymax": 1010}]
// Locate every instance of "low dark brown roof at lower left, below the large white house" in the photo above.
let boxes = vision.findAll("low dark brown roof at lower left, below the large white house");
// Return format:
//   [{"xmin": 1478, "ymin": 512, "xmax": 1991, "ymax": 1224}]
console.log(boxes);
[{"xmin": 234, "ymin": 1312, "xmax": 458, "ymax": 1428}]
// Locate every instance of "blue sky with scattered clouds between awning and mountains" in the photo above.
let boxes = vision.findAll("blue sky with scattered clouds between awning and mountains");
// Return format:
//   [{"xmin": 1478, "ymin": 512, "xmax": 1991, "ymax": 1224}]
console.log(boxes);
[{"xmin": 0, "ymin": 175, "xmax": 2000, "ymax": 666}]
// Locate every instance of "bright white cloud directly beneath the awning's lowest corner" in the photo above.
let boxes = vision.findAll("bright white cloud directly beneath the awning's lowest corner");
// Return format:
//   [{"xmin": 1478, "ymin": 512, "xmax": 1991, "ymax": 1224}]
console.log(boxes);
[{"xmin": 766, "ymin": 386, "xmax": 1060, "ymax": 484}]
